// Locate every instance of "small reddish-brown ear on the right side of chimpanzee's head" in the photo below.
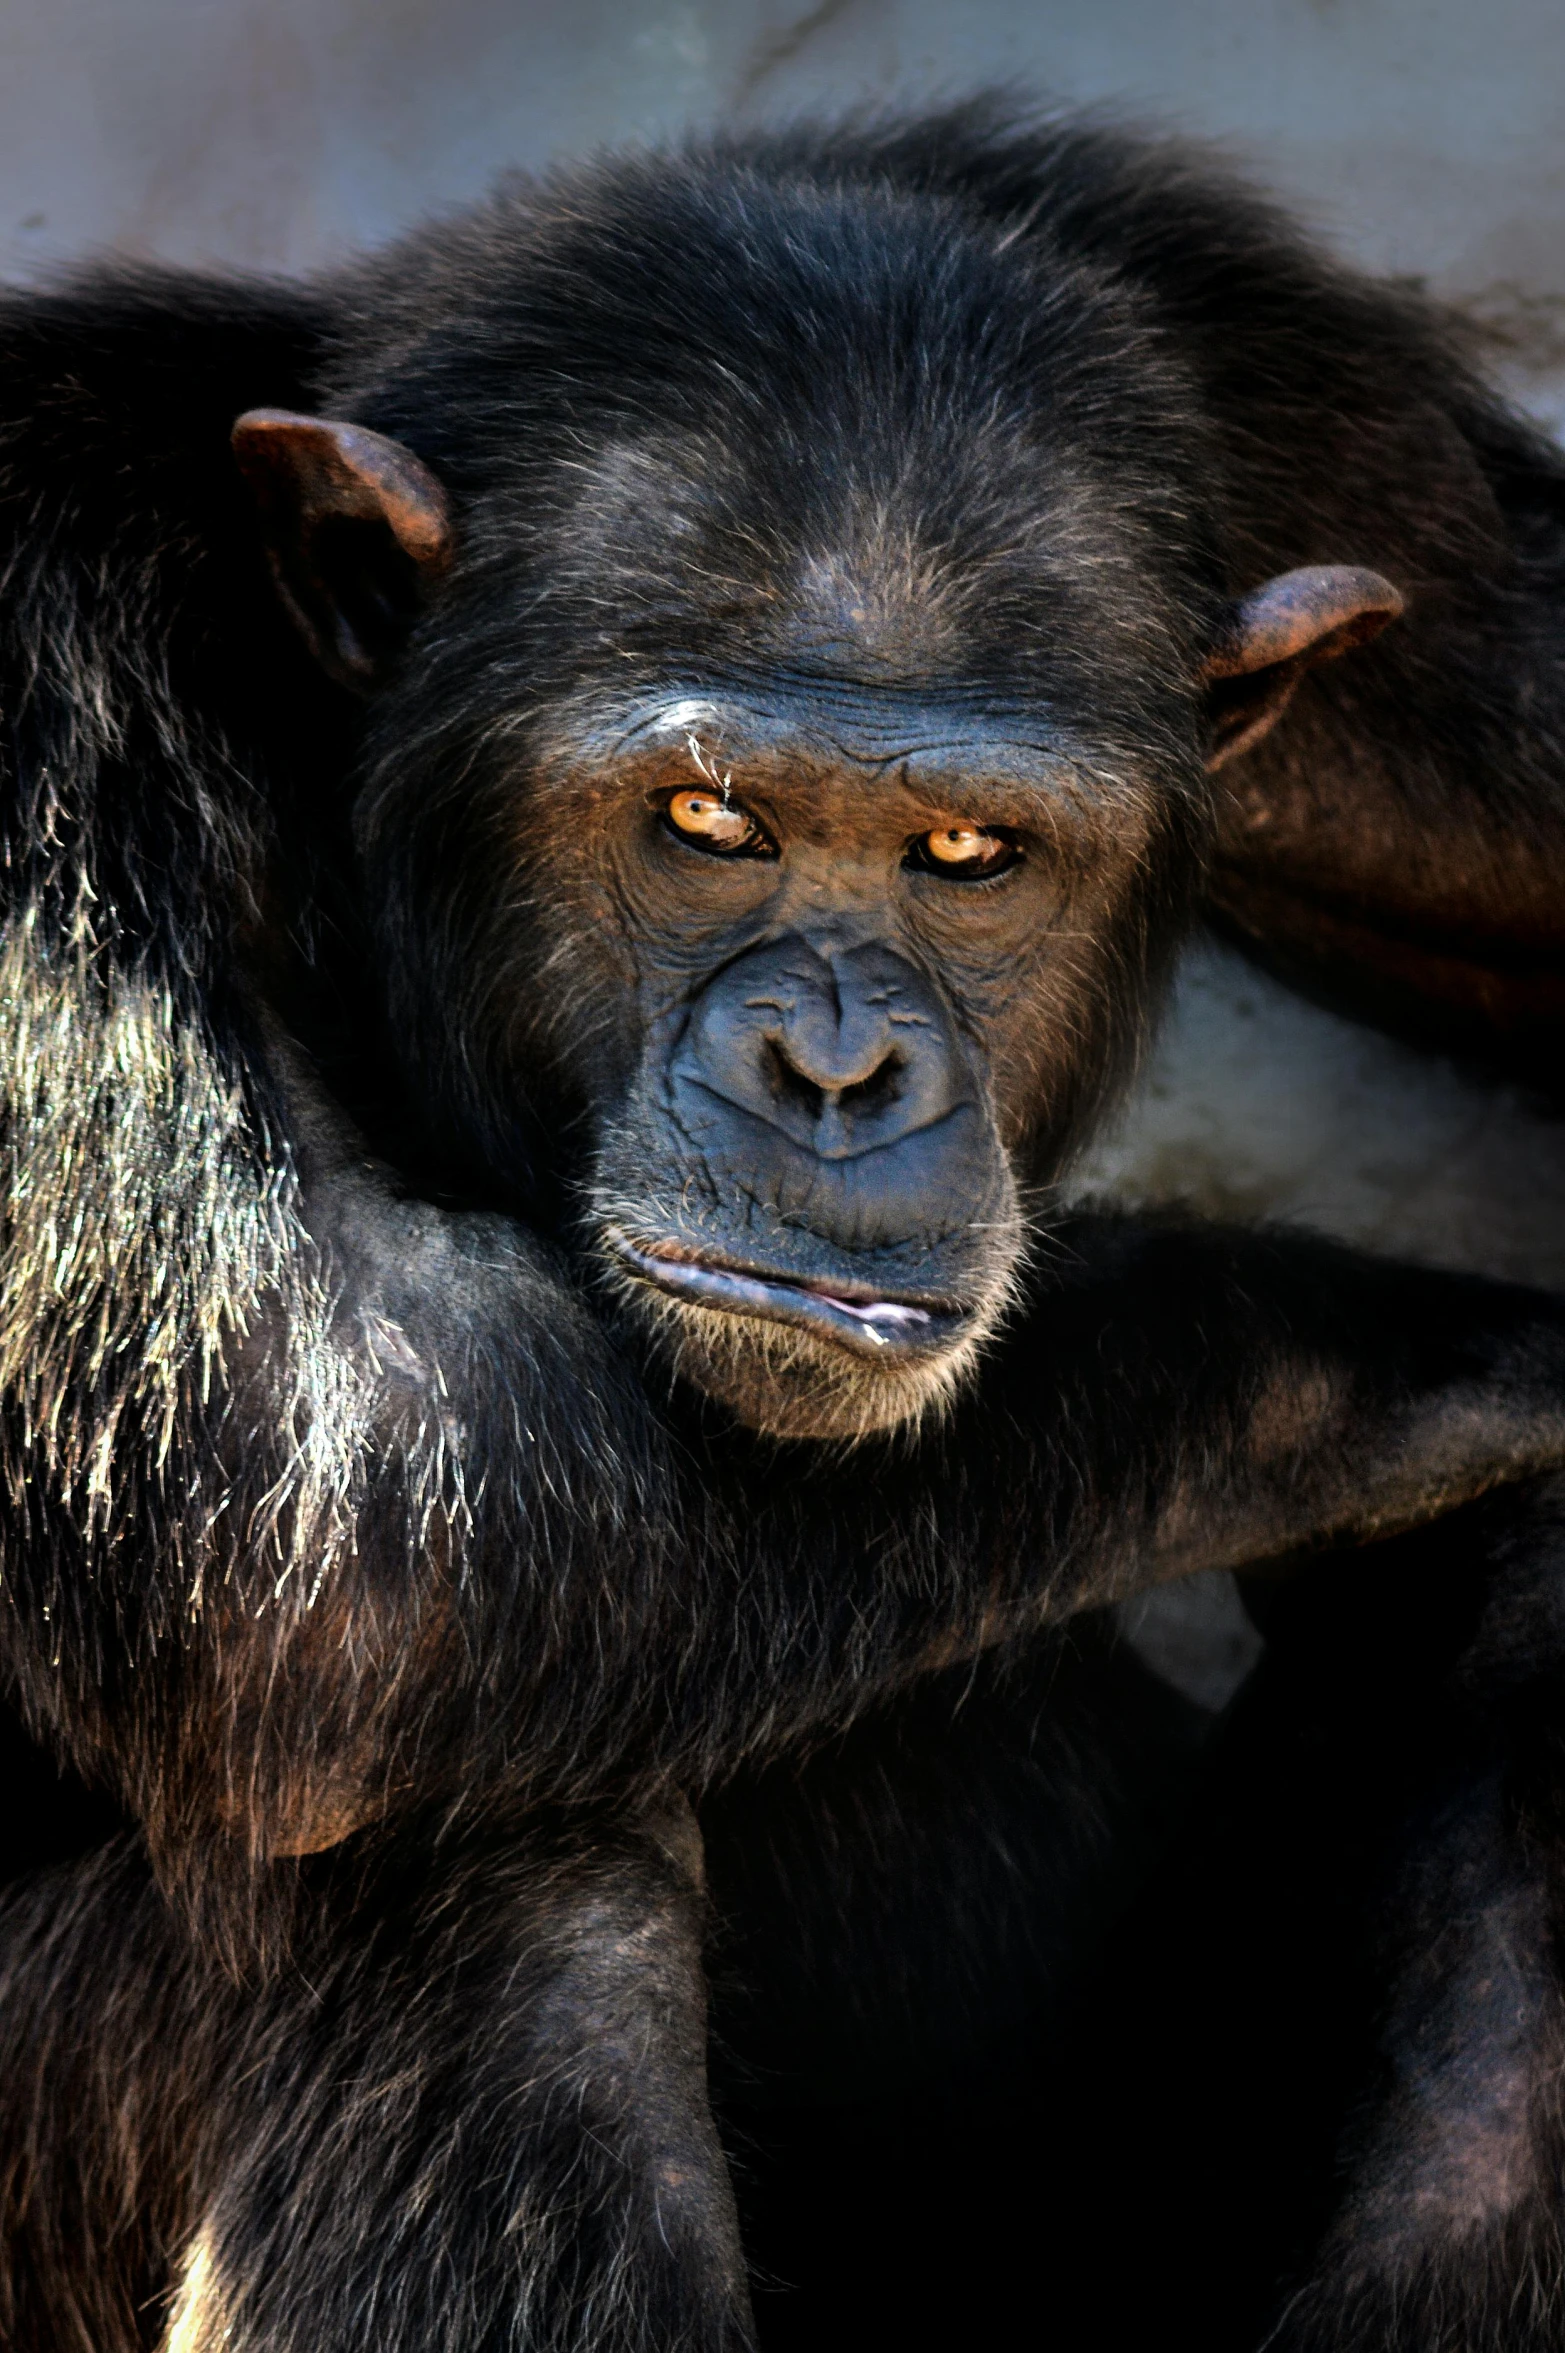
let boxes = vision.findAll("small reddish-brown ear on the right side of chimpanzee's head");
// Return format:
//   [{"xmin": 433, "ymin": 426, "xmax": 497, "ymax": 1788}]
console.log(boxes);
[{"xmin": 1200, "ymin": 565, "xmax": 1403, "ymax": 767}]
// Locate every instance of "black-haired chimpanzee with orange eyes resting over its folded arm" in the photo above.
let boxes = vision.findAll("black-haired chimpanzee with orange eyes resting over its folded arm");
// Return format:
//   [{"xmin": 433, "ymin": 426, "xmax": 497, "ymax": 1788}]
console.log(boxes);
[{"xmin": 0, "ymin": 106, "xmax": 1565, "ymax": 2353}]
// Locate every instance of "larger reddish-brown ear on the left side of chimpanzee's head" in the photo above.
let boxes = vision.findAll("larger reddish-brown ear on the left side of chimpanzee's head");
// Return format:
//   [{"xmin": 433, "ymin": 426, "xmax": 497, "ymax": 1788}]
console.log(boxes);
[{"xmin": 233, "ymin": 409, "xmax": 452, "ymax": 694}]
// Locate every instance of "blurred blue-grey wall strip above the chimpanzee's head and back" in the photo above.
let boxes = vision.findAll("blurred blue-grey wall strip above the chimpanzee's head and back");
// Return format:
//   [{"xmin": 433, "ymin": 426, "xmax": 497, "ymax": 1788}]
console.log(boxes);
[{"xmin": 0, "ymin": 0, "xmax": 1565, "ymax": 421}]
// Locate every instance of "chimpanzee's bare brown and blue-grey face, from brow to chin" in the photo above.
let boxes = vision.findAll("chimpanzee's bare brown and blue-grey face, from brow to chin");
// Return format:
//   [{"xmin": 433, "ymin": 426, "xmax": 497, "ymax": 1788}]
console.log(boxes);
[{"xmin": 522, "ymin": 699, "xmax": 1171, "ymax": 1438}]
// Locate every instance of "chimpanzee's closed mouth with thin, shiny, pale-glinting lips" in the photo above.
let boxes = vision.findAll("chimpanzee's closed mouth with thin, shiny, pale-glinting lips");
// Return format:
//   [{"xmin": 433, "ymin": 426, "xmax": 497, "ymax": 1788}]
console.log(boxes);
[{"xmin": 605, "ymin": 1233, "xmax": 972, "ymax": 1362}]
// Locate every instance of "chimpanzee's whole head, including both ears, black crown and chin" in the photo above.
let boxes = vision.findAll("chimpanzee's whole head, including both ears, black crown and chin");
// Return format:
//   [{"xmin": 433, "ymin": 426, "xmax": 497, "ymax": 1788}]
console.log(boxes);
[{"xmin": 235, "ymin": 151, "xmax": 1400, "ymax": 1438}]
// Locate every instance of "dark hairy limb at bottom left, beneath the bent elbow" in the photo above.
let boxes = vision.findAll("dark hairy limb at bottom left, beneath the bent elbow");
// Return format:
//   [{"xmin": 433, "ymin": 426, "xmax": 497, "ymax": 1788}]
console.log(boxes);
[{"xmin": 0, "ymin": 1807, "xmax": 753, "ymax": 2353}]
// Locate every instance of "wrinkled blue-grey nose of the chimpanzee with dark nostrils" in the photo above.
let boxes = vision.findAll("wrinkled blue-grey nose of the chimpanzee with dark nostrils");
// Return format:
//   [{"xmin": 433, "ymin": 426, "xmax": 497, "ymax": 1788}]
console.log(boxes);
[{"xmin": 671, "ymin": 939, "xmax": 970, "ymax": 1160}]
